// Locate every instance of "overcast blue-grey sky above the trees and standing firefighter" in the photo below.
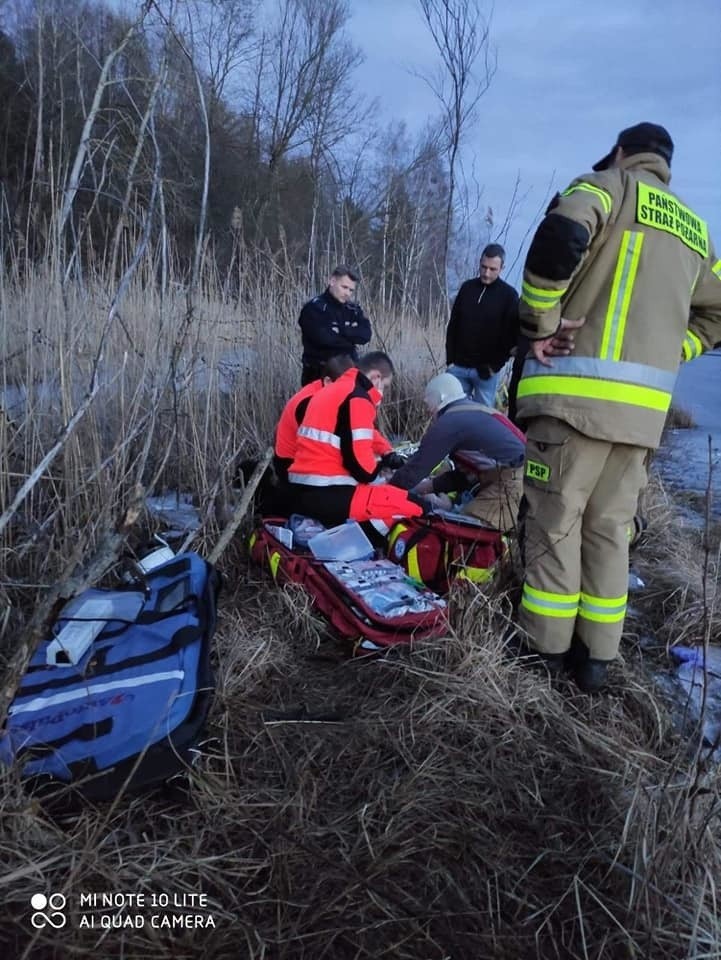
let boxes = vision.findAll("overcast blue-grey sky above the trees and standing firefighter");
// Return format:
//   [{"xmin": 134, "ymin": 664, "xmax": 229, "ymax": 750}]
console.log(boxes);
[{"xmin": 348, "ymin": 0, "xmax": 721, "ymax": 282}]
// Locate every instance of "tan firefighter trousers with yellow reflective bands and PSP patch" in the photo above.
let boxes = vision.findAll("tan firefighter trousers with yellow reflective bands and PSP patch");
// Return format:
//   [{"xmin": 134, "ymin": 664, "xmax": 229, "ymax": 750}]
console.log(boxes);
[{"xmin": 519, "ymin": 417, "xmax": 648, "ymax": 660}]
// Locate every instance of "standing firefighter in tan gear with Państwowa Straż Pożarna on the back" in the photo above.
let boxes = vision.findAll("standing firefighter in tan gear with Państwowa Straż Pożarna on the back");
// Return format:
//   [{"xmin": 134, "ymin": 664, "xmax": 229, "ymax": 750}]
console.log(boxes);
[{"xmin": 518, "ymin": 123, "xmax": 721, "ymax": 692}]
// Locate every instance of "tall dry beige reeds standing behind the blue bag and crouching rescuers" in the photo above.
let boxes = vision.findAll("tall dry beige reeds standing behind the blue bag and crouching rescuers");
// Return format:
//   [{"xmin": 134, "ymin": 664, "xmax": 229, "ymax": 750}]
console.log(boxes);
[{"xmin": 0, "ymin": 254, "xmax": 442, "ymax": 621}]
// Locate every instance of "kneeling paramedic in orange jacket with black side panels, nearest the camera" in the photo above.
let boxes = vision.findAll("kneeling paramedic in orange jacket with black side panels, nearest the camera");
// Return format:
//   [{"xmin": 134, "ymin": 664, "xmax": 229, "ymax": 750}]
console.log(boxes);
[{"xmin": 288, "ymin": 352, "xmax": 424, "ymax": 526}]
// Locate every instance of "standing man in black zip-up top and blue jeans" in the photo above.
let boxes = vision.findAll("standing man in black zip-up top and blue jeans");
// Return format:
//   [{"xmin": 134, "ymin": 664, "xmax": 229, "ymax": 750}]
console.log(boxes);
[{"xmin": 446, "ymin": 243, "xmax": 518, "ymax": 407}]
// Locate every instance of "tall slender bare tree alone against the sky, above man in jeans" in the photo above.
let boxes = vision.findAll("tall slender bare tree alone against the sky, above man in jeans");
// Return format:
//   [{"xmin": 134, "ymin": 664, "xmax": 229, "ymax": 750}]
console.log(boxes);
[{"xmin": 419, "ymin": 0, "xmax": 496, "ymax": 286}]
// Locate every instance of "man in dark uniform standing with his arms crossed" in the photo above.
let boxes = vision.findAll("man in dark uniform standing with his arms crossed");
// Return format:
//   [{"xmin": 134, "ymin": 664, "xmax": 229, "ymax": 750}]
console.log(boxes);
[{"xmin": 298, "ymin": 264, "xmax": 371, "ymax": 387}]
